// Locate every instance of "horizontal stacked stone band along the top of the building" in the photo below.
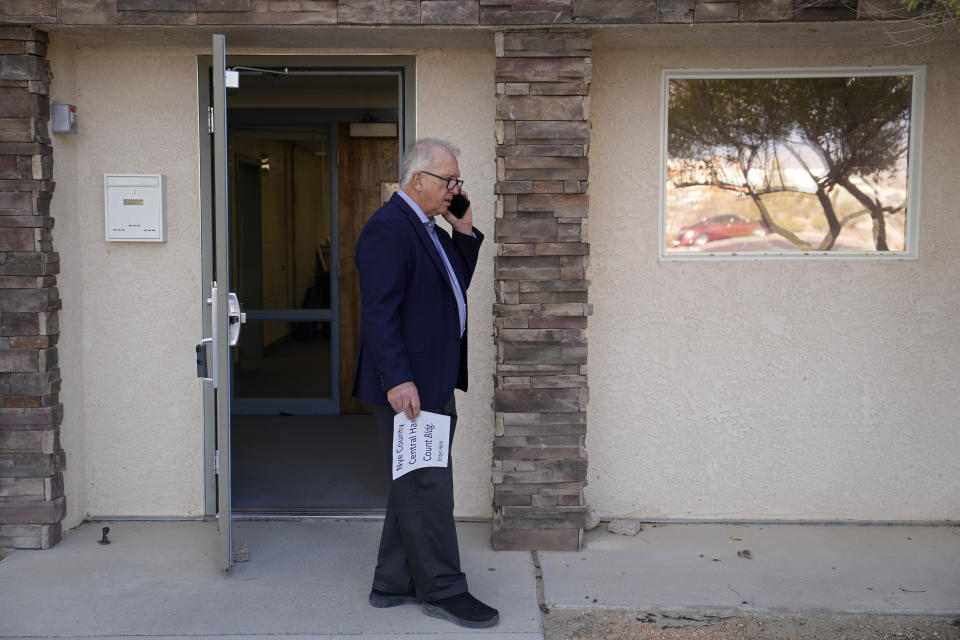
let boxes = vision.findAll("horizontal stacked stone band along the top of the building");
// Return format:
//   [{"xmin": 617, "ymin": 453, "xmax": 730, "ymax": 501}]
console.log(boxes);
[{"xmin": 0, "ymin": 0, "xmax": 907, "ymax": 27}]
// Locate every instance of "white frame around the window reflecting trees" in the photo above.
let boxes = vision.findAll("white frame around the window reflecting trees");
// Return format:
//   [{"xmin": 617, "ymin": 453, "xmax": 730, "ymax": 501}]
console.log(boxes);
[{"xmin": 657, "ymin": 65, "xmax": 926, "ymax": 262}]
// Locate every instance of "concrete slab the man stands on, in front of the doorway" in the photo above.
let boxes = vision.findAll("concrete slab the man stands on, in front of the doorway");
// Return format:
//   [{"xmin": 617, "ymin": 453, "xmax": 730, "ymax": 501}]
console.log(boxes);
[{"xmin": 0, "ymin": 521, "xmax": 543, "ymax": 640}]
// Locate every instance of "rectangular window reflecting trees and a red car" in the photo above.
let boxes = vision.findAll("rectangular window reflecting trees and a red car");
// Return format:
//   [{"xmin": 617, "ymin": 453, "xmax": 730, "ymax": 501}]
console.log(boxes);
[{"xmin": 660, "ymin": 67, "xmax": 923, "ymax": 260}]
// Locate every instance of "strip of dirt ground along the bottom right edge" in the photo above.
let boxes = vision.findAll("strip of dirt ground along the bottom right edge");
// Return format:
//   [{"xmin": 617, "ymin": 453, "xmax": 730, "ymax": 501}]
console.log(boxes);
[{"xmin": 543, "ymin": 610, "xmax": 960, "ymax": 640}]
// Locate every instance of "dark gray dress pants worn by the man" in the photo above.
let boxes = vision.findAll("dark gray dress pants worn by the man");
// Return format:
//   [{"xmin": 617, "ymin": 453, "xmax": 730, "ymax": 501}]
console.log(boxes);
[{"xmin": 372, "ymin": 398, "xmax": 467, "ymax": 602}]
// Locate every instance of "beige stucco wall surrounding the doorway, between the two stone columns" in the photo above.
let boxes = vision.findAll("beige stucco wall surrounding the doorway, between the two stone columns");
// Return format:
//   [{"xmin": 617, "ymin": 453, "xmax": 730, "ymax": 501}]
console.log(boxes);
[{"xmin": 50, "ymin": 41, "xmax": 495, "ymax": 526}]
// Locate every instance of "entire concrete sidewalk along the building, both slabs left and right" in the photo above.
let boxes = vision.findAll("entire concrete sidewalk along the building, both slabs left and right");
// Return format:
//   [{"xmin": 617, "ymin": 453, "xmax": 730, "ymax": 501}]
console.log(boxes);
[{"xmin": 0, "ymin": 520, "xmax": 960, "ymax": 640}]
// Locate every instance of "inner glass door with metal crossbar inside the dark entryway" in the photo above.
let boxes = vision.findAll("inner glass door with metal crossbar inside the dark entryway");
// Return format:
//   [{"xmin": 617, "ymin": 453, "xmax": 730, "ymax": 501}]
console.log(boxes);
[{"xmin": 229, "ymin": 132, "xmax": 340, "ymax": 415}]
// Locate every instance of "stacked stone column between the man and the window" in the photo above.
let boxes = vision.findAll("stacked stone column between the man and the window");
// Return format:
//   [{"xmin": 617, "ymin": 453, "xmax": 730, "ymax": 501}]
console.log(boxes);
[{"xmin": 493, "ymin": 30, "xmax": 591, "ymax": 550}]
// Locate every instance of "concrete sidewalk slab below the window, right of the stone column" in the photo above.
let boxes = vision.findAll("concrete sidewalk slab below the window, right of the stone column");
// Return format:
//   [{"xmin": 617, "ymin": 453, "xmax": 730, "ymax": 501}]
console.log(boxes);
[{"xmin": 538, "ymin": 524, "xmax": 960, "ymax": 615}]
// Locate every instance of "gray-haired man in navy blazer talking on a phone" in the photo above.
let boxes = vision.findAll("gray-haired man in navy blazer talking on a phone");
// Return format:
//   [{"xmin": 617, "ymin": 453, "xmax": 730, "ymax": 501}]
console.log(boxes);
[{"xmin": 353, "ymin": 139, "xmax": 499, "ymax": 628}]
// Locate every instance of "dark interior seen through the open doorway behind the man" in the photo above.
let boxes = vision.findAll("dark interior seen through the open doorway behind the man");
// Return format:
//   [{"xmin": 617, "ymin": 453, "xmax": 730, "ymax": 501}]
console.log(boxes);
[{"xmin": 206, "ymin": 57, "xmax": 412, "ymax": 515}]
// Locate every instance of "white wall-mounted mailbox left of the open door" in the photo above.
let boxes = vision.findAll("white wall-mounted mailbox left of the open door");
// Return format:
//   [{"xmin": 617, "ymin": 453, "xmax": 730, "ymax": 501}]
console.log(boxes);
[{"xmin": 103, "ymin": 173, "xmax": 166, "ymax": 242}]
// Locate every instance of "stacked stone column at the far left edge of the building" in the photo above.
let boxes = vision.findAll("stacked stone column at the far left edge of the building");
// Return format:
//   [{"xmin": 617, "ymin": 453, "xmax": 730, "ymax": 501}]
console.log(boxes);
[{"xmin": 0, "ymin": 25, "xmax": 66, "ymax": 556}]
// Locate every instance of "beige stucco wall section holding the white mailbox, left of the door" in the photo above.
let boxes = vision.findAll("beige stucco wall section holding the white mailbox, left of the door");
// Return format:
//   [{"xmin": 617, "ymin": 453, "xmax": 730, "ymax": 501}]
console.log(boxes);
[{"xmin": 50, "ymin": 47, "xmax": 203, "ymax": 525}]
